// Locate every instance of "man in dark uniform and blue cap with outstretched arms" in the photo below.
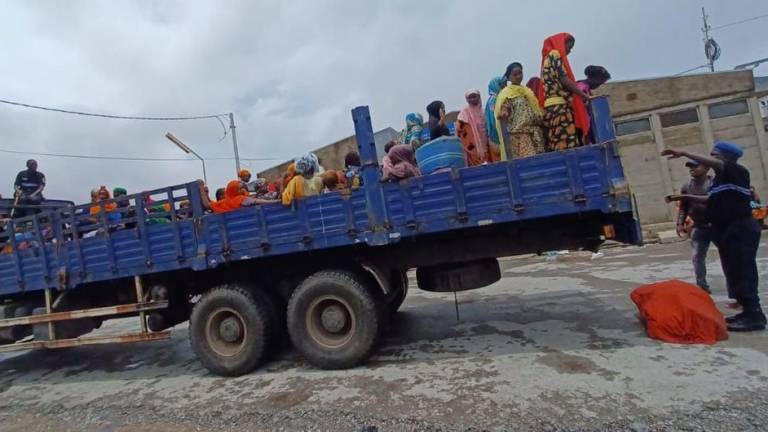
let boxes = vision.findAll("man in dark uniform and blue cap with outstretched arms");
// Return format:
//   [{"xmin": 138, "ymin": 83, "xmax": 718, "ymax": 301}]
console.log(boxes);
[{"xmin": 661, "ymin": 142, "xmax": 766, "ymax": 331}]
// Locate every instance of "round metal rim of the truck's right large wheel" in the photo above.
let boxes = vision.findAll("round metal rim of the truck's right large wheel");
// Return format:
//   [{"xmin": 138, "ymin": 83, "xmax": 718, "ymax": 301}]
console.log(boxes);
[{"xmin": 306, "ymin": 295, "xmax": 357, "ymax": 348}]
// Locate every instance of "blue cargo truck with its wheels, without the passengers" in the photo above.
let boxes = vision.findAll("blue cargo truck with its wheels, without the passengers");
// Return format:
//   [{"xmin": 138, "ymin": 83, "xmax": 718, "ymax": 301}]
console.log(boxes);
[{"xmin": 0, "ymin": 101, "xmax": 642, "ymax": 376}]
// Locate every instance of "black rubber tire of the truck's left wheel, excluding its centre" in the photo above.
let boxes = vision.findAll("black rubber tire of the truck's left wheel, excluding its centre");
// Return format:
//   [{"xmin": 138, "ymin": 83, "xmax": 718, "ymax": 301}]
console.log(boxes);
[{"xmin": 189, "ymin": 285, "xmax": 275, "ymax": 376}]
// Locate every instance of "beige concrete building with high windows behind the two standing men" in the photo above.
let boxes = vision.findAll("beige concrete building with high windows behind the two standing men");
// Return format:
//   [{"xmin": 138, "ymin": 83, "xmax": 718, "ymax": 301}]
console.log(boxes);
[{"xmin": 598, "ymin": 71, "xmax": 768, "ymax": 229}]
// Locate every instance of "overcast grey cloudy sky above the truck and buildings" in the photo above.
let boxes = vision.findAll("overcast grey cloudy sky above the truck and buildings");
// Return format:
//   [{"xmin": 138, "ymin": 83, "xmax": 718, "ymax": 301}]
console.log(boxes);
[{"xmin": 0, "ymin": 0, "xmax": 768, "ymax": 202}]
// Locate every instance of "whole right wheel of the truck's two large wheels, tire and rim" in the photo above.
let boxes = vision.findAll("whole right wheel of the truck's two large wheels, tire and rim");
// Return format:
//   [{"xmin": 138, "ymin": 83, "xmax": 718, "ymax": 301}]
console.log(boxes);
[{"xmin": 287, "ymin": 271, "xmax": 383, "ymax": 369}]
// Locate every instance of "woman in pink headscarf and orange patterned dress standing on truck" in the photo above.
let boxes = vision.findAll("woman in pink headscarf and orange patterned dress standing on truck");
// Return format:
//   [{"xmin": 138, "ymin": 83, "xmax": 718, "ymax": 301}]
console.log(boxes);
[{"xmin": 456, "ymin": 89, "xmax": 494, "ymax": 166}]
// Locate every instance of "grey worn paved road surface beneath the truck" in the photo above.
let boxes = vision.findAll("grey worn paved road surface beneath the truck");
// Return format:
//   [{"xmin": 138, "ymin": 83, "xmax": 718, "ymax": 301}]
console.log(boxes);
[{"xmin": 0, "ymin": 243, "xmax": 768, "ymax": 432}]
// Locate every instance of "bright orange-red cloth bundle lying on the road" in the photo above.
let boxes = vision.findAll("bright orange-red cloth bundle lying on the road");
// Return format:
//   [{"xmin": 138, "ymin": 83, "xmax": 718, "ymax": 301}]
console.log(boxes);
[{"xmin": 630, "ymin": 280, "xmax": 728, "ymax": 345}]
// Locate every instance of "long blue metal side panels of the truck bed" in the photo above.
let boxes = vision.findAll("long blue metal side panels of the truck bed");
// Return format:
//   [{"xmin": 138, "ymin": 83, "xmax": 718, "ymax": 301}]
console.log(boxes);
[{"xmin": 0, "ymin": 138, "xmax": 641, "ymax": 296}]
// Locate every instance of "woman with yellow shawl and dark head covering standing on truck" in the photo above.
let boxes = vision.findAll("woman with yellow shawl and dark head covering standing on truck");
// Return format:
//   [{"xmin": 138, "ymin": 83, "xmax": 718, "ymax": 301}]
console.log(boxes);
[{"xmin": 494, "ymin": 63, "xmax": 544, "ymax": 160}]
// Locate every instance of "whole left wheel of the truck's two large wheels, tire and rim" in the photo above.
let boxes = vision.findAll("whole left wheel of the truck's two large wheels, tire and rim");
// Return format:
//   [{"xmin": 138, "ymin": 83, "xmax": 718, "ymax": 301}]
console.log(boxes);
[{"xmin": 189, "ymin": 285, "xmax": 275, "ymax": 376}]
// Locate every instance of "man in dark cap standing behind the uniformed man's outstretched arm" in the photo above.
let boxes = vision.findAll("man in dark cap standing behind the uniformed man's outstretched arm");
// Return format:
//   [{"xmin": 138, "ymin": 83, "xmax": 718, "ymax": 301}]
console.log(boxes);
[{"xmin": 677, "ymin": 161, "xmax": 712, "ymax": 295}]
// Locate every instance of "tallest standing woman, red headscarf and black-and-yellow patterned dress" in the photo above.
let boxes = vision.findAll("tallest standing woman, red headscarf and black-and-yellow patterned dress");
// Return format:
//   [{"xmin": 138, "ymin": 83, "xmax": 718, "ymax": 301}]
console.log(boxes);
[{"xmin": 538, "ymin": 33, "xmax": 589, "ymax": 151}]
